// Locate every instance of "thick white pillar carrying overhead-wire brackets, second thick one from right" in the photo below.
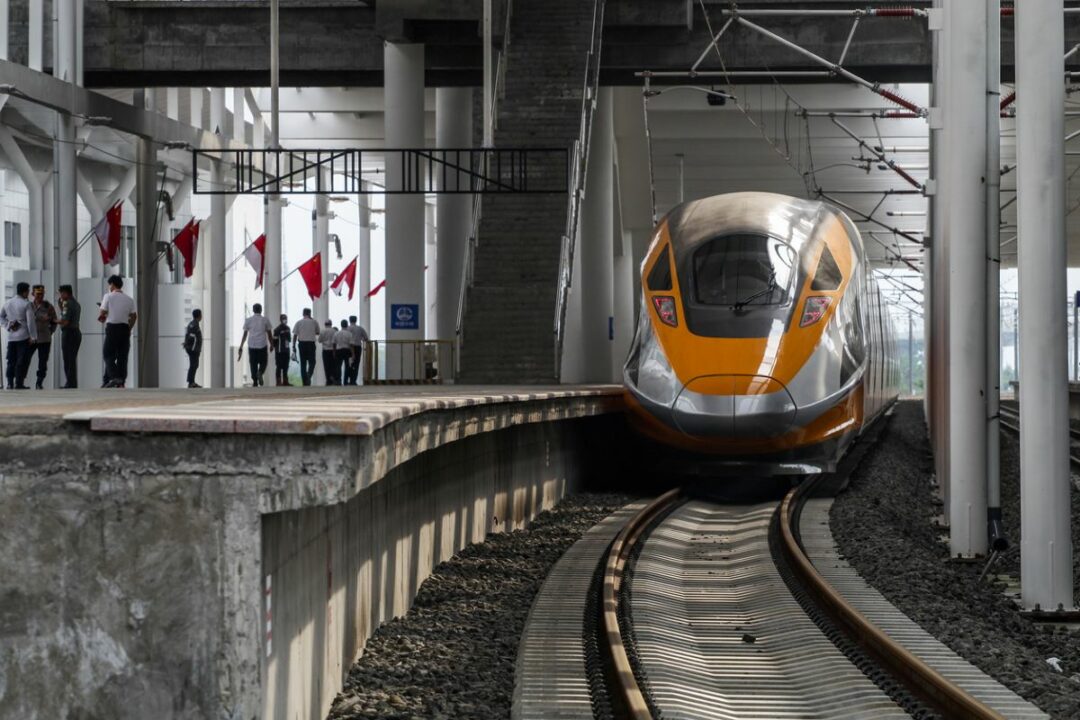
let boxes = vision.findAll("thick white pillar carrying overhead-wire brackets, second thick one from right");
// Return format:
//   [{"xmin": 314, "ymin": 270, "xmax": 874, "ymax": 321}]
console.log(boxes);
[{"xmin": 940, "ymin": 2, "xmax": 987, "ymax": 557}]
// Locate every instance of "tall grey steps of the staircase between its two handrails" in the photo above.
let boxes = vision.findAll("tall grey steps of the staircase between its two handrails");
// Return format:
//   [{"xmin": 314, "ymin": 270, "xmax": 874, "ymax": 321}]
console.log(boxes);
[{"xmin": 459, "ymin": 0, "xmax": 594, "ymax": 384}]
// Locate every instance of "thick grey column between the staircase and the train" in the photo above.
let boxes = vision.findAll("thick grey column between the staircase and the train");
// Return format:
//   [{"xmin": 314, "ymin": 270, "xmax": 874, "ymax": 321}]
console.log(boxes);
[{"xmin": 573, "ymin": 87, "xmax": 615, "ymax": 382}]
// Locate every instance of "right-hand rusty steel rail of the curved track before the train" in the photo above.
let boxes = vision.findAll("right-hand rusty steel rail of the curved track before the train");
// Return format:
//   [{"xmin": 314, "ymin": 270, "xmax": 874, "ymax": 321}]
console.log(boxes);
[{"xmin": 780, "ymin": 483, "xmax": 1004, "ymax": 720}]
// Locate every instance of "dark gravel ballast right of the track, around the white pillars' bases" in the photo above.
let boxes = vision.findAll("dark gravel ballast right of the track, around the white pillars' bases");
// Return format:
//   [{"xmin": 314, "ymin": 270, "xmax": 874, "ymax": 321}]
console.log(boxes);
[{"xmin": 831, "ymin": 400, "xmax": 1080, "ymax": 718}]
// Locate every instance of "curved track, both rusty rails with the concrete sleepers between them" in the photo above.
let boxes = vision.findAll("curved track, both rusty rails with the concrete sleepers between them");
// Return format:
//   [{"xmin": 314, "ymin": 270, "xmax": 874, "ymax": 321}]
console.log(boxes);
[{"xmin": 600, "ymin": 483, "xmax": 1002, "ymax": 720}]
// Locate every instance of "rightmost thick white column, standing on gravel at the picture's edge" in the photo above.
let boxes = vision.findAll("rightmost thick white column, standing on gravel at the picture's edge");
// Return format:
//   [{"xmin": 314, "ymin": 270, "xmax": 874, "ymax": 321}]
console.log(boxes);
[{"xmin": 1016, "ymin": 0, "xmax": 1072, "ymax": 610}]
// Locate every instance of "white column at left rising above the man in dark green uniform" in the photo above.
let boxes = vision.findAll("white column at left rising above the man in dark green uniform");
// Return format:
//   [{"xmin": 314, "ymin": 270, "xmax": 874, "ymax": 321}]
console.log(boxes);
[{"xmin": 53, "ymin": 0, "xmax": 79, "ymax": 289}]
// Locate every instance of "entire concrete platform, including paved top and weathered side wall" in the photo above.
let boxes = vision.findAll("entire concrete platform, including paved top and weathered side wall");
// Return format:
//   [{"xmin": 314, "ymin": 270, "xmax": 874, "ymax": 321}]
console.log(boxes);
[{"xmin": 0, "ymin": 385, "xmax": 622, "ymax": 719}]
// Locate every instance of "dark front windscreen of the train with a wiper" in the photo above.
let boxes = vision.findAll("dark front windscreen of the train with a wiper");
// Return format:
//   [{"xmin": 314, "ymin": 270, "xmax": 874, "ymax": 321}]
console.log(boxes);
[{"xmin": 693, "ymin": 234, "xmax": 797, "ymax": 308}]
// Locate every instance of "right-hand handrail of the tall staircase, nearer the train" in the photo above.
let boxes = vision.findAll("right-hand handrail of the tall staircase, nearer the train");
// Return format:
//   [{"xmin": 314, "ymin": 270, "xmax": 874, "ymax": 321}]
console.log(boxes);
[{"xmin": 554, "ymin": 0, "xmax": 604, "ymax": 382}]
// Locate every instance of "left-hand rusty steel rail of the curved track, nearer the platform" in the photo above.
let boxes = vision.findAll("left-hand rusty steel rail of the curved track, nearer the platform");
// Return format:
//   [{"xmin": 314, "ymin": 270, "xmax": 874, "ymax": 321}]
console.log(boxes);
[{"xmin": 600, "ymin": 488, "xmax": 681, "ymax": 720}]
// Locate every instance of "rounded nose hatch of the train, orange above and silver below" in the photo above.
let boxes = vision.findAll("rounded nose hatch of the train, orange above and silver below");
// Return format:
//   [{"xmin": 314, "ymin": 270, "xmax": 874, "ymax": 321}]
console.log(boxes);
[{"xmin": 672, "ymin": 375, "xmax": 797, "ymax": 437}]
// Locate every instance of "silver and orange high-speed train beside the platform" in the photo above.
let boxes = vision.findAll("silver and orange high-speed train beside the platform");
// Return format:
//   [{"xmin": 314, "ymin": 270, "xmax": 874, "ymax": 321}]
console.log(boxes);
[{"xmin": 623, "ymin": 192, "xmax": 899, "ymax": 475}]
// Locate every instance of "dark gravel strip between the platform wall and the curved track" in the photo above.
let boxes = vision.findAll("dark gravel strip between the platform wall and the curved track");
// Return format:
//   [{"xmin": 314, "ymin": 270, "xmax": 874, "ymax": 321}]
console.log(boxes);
[{"xmin": 329, "ymin": 493, "xmax": 633, "ymax": 720}]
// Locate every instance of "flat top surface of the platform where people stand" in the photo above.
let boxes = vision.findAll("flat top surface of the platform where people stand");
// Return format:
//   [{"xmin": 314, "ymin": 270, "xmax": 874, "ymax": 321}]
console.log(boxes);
[{"xmin": 0, "ymin": 385, "xmax": 622, "ymax": 435}]
